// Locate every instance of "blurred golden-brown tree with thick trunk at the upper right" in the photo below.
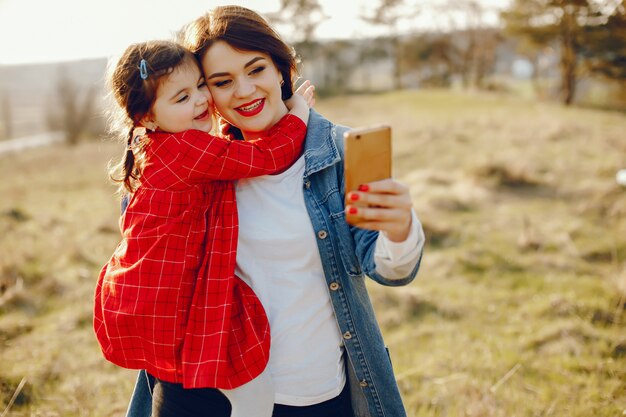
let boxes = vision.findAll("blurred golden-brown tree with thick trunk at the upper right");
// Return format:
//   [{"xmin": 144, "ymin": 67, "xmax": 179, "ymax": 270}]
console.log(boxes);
[{"xmin": 502, "ymin": 0, "xmax": 622, "ymax": 105}]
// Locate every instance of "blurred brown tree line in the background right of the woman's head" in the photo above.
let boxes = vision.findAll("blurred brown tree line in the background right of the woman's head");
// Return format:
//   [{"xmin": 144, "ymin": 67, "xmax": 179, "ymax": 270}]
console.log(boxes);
[{"xmin": 269, "ymin": 0, "xmax": 626, "ymax": 105}]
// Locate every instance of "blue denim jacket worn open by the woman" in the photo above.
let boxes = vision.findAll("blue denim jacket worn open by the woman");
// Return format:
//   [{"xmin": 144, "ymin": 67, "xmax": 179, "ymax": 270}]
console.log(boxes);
[{"xmin": 127, "ymin": 110, "xmax": 421, "ymax": 417}]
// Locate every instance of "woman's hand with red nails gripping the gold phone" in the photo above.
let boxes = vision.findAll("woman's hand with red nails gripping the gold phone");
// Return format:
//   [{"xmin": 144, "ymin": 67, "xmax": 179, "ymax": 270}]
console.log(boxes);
[{"xmin": 346, "ymin": 179, "xmax": 413, "ymax": 242}]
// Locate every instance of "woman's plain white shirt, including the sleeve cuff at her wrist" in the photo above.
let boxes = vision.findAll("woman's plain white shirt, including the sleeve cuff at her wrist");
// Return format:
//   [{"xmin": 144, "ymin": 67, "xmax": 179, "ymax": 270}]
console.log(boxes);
[{"xmin": 236, "ymin": 157, "xmax": 424, "ymax": 406}]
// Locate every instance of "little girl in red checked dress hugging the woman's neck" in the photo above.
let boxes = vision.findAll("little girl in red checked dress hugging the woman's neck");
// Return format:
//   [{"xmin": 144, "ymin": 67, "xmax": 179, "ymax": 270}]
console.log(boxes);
[{"xmin": 94, "ymin": 41, "xmax": 313, "ymax": 417}]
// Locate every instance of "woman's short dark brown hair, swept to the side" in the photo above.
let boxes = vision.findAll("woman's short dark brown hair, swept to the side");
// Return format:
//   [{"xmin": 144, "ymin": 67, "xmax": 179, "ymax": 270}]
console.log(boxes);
[{"xmin": 179, "ymin": 6, "xmax": 298, "ymax": 100}]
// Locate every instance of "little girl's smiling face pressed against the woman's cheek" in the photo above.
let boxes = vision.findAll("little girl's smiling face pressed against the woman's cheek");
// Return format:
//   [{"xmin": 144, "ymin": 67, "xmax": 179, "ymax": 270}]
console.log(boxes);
[{"xmin": 142, "ymin": 62, "xmax": 213, "ymax": 133}]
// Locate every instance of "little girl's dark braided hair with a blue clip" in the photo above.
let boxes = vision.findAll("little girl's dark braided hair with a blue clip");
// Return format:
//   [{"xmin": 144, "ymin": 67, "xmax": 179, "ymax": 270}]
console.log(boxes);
[{"xmin": 108, "ymin": 41, "xmax": 198, "ymax": 193}]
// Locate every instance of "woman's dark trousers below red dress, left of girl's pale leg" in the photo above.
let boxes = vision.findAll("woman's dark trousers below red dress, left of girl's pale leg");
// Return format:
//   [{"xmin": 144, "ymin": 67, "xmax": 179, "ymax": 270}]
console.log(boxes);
[{"xmin": 152, "ymin": 378, "xmax": 231, "ymax": 417}]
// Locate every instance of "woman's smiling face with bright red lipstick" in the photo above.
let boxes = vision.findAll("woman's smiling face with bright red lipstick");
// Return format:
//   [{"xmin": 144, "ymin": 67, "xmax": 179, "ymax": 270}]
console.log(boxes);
[{"xmin": 202, "ymin": 41, "xmax": 287, "ymax": 139}]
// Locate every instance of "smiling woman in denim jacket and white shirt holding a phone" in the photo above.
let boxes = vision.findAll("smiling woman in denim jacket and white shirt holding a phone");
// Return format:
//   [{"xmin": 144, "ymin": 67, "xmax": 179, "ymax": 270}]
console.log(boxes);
[{"xmin": 128, "ymin": 6, "xmax": 424, "ymax": 417}]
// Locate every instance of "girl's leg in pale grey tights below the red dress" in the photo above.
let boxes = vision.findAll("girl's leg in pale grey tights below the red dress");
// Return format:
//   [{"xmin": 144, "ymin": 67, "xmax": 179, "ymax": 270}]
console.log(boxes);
[{"xmin": 221, "ymin": 368, "xmax": 274, "ymax": 417}]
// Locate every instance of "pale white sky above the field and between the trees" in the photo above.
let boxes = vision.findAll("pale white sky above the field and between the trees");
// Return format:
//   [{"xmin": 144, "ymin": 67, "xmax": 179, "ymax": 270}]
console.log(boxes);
[{"xmin": 0, "ymin": 0, "xmax": 505, "ymax": 65}]
